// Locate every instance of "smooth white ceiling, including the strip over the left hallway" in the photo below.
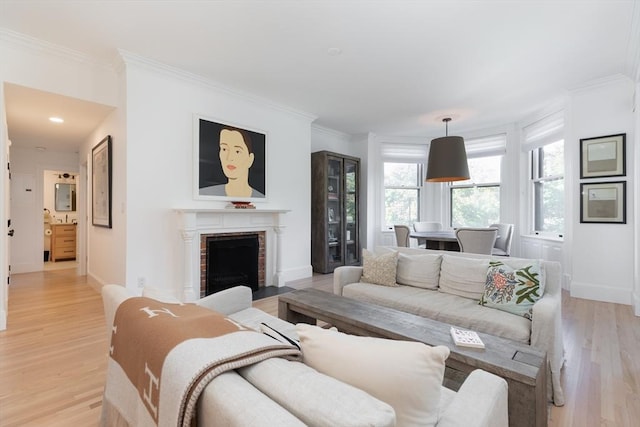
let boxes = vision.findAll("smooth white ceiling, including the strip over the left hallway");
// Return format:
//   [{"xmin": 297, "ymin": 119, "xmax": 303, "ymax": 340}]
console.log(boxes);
[{"xmin": 0, "ymin": 0, "xmax": 640, "ymax": 152}]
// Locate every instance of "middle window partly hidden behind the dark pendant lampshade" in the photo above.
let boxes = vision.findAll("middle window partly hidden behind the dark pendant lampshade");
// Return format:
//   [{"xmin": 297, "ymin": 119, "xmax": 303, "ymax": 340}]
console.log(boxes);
[{"xmin": 450, "ymin": 156, "xmax": 502, "ymax": 228}]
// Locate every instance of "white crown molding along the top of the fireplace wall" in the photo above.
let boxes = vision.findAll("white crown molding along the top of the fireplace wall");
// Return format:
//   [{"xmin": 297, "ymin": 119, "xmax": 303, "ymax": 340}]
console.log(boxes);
[{"xmin": 118, "ymin": 49, "xmax": 317, "ymax": 122}]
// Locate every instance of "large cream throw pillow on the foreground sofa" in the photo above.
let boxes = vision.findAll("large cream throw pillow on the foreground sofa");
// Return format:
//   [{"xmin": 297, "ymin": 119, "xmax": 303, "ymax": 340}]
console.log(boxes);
[{"xmin": 296, "ymin": 323, "xmax": 449, "ymax": 426}]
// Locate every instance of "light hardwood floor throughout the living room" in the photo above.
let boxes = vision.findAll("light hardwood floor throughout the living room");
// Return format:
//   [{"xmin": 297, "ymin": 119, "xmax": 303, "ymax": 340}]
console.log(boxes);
[{"xmin": 0, "ymin": 269, "xmax": 640, "ymax": 427}]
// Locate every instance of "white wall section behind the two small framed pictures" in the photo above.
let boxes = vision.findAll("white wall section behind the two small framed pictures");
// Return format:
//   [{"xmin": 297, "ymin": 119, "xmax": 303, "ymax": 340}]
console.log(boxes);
[{"xmin": 565, "ymin": 77, "xmax": 638, "ymax": 304}]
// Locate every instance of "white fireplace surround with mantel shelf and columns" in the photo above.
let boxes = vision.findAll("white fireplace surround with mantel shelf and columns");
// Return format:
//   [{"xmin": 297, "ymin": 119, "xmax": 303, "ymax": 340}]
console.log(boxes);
[{"xmin": 176, "ymin": 208, "xmax": 289, "ymax": 302}]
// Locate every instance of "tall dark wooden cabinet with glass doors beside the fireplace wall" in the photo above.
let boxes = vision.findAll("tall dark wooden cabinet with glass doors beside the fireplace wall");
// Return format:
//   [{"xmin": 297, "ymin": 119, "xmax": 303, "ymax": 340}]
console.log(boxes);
[{"xmin": 311, "ymin": 151, "xmax": 361, "ymax": 273}]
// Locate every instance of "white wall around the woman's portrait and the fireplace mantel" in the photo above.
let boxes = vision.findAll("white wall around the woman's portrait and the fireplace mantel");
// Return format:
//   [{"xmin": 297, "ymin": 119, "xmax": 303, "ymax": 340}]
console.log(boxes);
[{"xmin": 116, "ymin": 55, "xmax": 313, "ymax": 298}]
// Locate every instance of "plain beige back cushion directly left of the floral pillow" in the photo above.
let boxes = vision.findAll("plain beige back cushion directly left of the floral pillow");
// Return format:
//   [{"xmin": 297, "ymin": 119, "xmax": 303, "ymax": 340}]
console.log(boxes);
[{"xmin": 439, "ymin": 254, "xmax": 490, "ymax": 301}]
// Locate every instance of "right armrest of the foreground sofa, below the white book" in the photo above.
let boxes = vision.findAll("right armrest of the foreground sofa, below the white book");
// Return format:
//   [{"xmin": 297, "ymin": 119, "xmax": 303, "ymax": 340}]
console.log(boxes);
[{"xmin": 437, "ymin": 369, "xmax": 509, "ymax": 427}]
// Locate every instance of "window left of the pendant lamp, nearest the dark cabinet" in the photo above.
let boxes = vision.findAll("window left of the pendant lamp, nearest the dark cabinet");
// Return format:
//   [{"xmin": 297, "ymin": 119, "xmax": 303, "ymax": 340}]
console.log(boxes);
[{"xmin": 383, "ymin": 162, "xmax": 422, "ymax": 229}]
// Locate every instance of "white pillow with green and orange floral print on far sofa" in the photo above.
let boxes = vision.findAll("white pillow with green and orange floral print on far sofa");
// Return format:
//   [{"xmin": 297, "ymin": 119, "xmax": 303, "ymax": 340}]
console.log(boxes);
[{"xmin": 479, "ymin": 261, "xmax": 544, "ymax": 320}]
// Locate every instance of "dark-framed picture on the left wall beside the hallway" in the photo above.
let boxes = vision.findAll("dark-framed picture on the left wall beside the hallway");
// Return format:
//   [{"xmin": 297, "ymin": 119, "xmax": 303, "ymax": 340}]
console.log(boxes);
[{"xmin": 91, "ymin": 135, "xmax": 112, "ymax": 228}]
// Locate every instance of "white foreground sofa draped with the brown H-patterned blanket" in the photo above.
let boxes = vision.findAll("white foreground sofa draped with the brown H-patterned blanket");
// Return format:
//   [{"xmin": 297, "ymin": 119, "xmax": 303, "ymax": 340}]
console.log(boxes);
[{"xmin": 101, "ymin": 285, "xmax": 508, "ymax": 427}]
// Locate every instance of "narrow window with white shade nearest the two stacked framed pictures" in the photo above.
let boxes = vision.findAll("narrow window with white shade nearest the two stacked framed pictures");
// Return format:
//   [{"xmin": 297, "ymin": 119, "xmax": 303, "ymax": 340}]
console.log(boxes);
[{"xmin": 523, "ymin": 112, "xmax": 564, "ymax": 237}]
